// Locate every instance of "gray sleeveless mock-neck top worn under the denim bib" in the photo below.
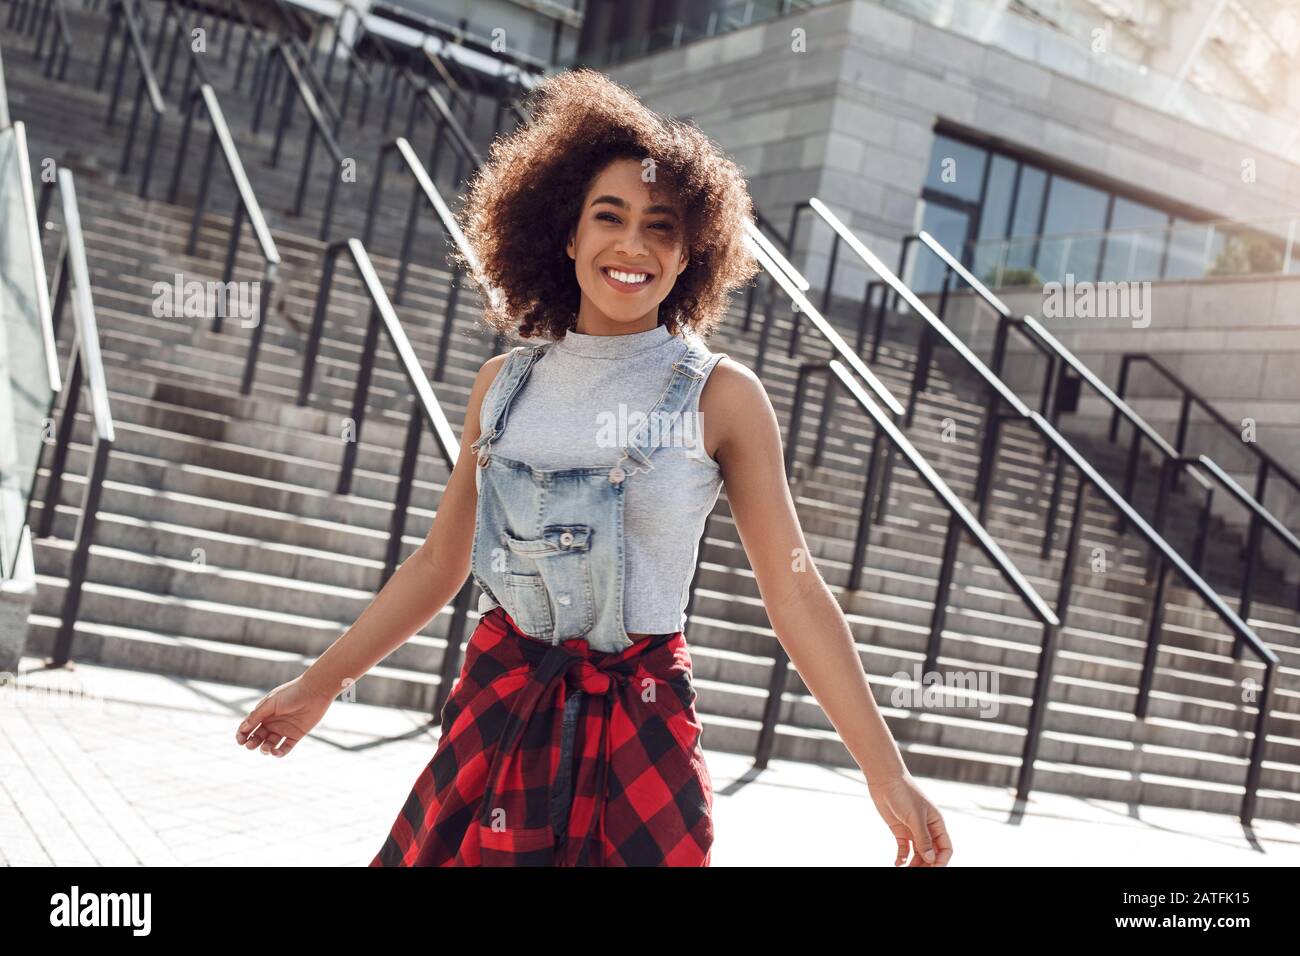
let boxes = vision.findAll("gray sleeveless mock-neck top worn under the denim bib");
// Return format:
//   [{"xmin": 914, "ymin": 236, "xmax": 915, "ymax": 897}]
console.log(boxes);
[{"xmin": 478, "ymin": 325, "xmax": 724, "ymax": 633}]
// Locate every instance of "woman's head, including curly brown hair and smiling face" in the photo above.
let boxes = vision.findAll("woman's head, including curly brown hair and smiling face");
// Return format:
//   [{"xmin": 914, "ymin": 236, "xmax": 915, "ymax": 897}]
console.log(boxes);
[{"xmin": 454, "ymin": 70, "xmax": 758, "ymax": 338}]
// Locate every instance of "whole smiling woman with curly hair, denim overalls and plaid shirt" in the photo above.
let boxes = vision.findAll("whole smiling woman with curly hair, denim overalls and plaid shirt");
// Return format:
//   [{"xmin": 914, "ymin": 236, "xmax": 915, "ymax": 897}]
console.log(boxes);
[{"xmin": 237, "ymin": 70, "xmax": 952, "ymax": 866}]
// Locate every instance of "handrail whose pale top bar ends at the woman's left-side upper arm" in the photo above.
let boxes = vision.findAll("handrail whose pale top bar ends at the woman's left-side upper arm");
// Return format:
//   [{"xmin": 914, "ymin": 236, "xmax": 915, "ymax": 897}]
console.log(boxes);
[{"xmin": 298, "ymin": 238, "xmax": 473, "ymax": 719}]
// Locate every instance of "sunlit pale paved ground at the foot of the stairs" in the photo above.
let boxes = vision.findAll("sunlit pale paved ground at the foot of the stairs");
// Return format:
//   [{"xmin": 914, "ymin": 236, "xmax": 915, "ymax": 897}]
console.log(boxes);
[{"xmin": 0, "ymin": 658, "xmax": 1300, "ymax": 868}]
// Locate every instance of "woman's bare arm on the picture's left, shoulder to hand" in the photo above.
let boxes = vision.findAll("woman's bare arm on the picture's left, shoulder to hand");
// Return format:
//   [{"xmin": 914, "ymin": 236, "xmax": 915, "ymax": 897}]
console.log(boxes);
[{"xmin": 235, "ymin": 355, "xmax": 506, "ymax": 756}]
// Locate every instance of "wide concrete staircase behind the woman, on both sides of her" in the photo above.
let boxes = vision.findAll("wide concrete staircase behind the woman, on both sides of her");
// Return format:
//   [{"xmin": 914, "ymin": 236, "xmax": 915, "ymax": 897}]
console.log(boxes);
[{"xmin": 5, "ymin": 4, "xmax": 1300, "ymax": 819}]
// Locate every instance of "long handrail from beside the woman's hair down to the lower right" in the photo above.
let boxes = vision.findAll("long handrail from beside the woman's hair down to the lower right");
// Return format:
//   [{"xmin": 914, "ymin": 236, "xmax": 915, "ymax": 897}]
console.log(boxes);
[{"xmin": 792, "ymin": 198, "xmax": 1278, "ymax": 823}]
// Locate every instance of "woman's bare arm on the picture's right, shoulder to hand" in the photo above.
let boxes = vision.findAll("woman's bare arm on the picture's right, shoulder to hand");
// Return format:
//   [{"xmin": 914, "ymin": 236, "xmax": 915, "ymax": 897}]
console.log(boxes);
[{"xmin": 699, "ymin": 359, "xmax": 952, "ymax": 866}]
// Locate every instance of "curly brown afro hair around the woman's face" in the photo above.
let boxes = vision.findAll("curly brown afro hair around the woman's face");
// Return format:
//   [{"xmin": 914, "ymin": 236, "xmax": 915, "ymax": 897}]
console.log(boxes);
[{"xmin": 450, "ymin": 69, "xmax": 759, "ymax": 339}]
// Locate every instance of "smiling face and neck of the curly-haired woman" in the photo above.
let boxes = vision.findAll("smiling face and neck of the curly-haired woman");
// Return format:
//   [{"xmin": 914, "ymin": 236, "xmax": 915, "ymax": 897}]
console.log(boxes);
[{"xmin": 567, "ymin": 159, "xmax": 689, "ymax": 334}]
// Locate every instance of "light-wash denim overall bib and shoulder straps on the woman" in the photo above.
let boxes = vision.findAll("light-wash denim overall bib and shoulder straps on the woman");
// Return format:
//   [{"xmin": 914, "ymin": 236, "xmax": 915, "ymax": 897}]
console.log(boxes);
[{"xmin": 471, "ymin": 339, "xmax": 723, "ymax": 652}]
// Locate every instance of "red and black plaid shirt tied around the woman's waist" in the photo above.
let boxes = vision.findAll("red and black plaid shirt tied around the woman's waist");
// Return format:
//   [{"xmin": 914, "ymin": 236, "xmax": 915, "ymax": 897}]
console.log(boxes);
[{"xmin": 371, "ymin": 607, "xmax": 714, "ymax": 866}]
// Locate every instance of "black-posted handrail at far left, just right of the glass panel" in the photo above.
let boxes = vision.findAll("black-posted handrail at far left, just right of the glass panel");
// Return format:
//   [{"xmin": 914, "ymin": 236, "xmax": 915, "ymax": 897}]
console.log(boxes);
[{"xmin": 28, "ymin": 169, "xmax": 116, "ymax": 667}]
